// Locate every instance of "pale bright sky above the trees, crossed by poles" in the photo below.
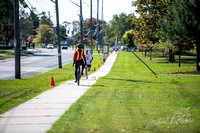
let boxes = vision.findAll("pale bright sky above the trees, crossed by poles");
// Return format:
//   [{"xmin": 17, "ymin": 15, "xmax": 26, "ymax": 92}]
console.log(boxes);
[{"xmin": 25, "ymin": 0, "xmax": 138, "ymax": 25}]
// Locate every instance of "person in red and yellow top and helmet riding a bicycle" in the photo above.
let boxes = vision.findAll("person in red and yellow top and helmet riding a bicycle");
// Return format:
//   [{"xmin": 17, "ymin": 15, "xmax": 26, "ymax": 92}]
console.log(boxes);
[{"xmin": 73, "ymin": 43, "xmax": 86, "ymax": 83}]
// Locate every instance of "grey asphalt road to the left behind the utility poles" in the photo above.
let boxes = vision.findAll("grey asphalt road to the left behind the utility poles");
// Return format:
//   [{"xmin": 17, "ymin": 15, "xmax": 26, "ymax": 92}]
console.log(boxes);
[{"xmin": 0, "ymin": 48, "xmax": 74, "ymax": 80}]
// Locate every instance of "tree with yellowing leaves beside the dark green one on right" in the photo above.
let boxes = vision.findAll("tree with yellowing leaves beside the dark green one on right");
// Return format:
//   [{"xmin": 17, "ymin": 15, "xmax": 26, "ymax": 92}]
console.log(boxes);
[{"xmin": 131, "ymin": 0, "xmax": 173, "ymax": 49}]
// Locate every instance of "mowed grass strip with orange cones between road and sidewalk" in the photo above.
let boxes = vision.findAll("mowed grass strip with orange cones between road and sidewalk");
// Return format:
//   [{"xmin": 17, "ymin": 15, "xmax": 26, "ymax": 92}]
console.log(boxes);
[{"xmin": 0, "ymin": 55, "xmax": 102, "ymax": 113}]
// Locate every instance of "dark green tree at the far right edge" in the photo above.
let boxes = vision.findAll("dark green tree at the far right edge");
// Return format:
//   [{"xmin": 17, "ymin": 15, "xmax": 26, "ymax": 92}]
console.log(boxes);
[{"xmin": 159, "ymin": 0, "xmax": 200, "ymax": 71}]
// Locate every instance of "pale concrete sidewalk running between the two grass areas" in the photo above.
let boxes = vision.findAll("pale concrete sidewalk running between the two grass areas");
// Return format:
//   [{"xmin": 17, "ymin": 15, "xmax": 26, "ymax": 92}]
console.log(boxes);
[{"xmin": 0, "ymin": 54, "xmax": 117, "ymax": 133}]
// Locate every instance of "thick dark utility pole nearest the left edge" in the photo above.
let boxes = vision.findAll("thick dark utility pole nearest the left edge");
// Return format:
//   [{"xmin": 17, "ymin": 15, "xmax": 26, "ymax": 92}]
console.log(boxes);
[{"xmin": 14, "ymin": 0, "xmax": 21, "ymax": 79}]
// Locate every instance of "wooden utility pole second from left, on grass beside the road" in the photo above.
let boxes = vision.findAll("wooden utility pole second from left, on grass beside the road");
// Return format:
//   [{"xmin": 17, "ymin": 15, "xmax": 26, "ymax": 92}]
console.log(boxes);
[{"xmin": 51, "ymin": 0, "xmax": 62, "ymax": 68}]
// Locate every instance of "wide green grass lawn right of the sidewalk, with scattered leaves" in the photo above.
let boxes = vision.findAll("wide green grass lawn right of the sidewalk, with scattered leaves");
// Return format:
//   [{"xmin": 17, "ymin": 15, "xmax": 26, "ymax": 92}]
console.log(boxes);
[{"xmin": 48, "ymin": 52, "xmax": 200, "ymax": 133}]
